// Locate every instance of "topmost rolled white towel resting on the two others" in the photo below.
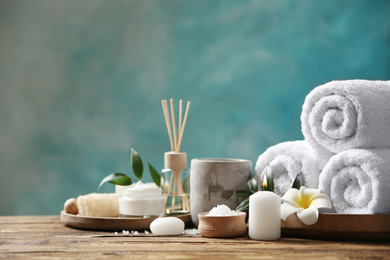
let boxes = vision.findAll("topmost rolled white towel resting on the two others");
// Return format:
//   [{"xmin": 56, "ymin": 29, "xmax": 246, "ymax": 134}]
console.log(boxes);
[{"xmin": 301, "ymin": 80, "xmax": 390, "ymax": 161}]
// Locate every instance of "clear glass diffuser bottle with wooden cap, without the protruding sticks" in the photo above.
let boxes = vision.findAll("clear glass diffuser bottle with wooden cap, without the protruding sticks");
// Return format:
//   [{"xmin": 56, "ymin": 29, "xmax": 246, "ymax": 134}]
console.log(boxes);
[{"xmin": 161, "ymin": 152, "xmax": 190, "ymax": 215}]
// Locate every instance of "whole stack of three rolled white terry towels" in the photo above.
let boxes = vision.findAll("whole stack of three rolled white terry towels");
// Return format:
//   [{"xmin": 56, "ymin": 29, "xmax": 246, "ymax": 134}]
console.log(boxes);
[{"xmin": 255, "ymin": 80, "xmax": 390, "ymax": 214}]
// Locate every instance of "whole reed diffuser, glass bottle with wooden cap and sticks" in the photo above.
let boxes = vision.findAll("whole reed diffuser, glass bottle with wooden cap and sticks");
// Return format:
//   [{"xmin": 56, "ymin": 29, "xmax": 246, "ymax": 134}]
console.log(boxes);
[{"xmin": 161, "ymin": 99, "xmax": 191, "ymax": 215}]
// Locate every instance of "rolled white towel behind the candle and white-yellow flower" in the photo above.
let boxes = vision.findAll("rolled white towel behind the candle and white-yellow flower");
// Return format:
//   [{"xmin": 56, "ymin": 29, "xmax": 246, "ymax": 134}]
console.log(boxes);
[{"xmin": 255, "ymin": 141, "xmax": 320, "ymax": 196}]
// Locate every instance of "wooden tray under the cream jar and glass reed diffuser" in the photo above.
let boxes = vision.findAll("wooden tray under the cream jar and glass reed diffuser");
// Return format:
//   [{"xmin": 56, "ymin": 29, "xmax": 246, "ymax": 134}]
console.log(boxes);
[{"xmin": 61, "ymin": 211, "xmax": 192, "ymax": 231}]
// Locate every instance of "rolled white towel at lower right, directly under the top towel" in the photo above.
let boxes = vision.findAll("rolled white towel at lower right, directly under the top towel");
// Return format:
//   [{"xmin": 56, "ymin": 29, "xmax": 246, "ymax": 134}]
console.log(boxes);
[{"xmin": 319, "ymin": 149, "xmax": 390, "ymax": 214}]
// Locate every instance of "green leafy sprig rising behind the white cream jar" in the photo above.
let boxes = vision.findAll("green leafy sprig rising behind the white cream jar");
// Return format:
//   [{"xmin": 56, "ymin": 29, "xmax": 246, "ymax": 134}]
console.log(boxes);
[{"xmin": 98, "ymin": 148, "xmax": 161, "ymax": 190}]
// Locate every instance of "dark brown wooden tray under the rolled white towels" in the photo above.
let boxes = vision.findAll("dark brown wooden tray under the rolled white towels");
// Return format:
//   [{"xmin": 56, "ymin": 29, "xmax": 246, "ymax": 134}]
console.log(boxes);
[{"xmin": 281, "ymin": 213, "xmax": 390, "ymax": 241}]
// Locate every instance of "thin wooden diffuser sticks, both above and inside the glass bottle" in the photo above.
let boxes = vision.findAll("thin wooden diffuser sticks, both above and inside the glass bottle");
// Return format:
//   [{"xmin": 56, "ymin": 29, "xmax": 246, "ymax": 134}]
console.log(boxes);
[{"xmin": 161, "ymin": 99, "xmax": 191, "ymax": 211}]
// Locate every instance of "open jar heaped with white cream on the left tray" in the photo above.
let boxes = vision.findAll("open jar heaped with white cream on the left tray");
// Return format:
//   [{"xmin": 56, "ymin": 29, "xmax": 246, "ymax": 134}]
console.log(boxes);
[{"xmin": 119, "ymin": 181, "xmax": 165, "ymax": 218}]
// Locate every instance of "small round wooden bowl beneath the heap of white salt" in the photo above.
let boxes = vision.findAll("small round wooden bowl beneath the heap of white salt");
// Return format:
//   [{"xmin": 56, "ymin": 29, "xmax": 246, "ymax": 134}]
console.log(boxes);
[{"xmin": 198, "ymin": 212, "xmax": 246, "ymax": 238}]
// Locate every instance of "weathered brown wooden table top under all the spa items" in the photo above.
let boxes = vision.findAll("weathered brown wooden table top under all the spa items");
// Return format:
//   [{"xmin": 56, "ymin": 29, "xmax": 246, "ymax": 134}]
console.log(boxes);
[{"xmin": 0, "ymin": 216, "xmax": 390, "ymax": 259}]
